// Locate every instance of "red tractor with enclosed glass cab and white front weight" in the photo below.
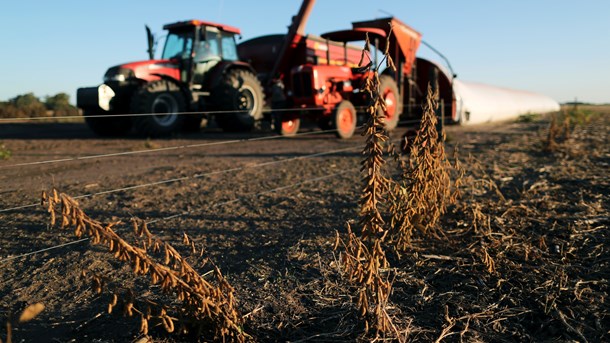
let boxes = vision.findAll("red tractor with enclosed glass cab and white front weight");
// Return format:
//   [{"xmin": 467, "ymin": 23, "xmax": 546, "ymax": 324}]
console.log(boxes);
[{"xmin": 77, "ymin": 20, "xmax": 264, "ymax": 136}]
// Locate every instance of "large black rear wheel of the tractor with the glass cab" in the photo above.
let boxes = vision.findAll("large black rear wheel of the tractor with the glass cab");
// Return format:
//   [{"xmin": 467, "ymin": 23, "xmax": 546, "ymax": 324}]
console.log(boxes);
[{"xmin": 212, "ymin": 69, "xmax": 264, "ymax": 132}]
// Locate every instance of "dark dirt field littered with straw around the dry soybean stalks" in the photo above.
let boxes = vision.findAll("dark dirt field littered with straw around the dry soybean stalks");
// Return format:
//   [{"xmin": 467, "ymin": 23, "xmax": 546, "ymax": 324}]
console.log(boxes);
[{"xmin": 0, "ymin": 111, "xmax": 610, "ymax": 342}]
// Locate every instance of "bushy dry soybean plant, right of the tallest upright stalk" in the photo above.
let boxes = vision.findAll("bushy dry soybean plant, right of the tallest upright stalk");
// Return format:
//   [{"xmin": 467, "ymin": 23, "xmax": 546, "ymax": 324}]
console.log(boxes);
[{"xmin": 389, "ymin": 86, "xmax": 464, "ymax": 251}]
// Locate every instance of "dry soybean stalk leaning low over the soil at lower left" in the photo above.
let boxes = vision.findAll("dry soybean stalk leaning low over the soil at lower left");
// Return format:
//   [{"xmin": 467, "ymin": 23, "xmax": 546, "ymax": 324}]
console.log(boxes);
[{"xmin": 42, "ymin": 190, "xmax": 247, "ymax": 342}]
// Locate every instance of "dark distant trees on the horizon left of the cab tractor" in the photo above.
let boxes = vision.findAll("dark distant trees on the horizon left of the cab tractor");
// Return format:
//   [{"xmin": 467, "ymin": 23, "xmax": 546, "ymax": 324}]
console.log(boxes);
[{"xmin": 0, "ymin": 93, "xmax": 79, "ymax": 118}]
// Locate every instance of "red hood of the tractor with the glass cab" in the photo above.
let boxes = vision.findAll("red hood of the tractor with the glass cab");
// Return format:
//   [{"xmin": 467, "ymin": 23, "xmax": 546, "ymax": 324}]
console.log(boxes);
[{"xmin": 104, "ymin": 60, "xmax": 180, "ymax": 83}]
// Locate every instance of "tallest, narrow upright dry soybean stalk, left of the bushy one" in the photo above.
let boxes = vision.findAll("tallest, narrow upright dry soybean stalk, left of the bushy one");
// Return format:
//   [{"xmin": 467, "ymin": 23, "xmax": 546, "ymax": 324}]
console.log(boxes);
[{"xmin": 337, "ymin": 32, "xmax": 394, "ymax": 335}]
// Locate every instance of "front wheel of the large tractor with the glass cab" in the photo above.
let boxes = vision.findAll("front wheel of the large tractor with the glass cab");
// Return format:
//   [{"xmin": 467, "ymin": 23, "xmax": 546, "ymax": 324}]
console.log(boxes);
[{"xmin": 131, "ymin": 80, "xmax": 186, "ymax": 137}]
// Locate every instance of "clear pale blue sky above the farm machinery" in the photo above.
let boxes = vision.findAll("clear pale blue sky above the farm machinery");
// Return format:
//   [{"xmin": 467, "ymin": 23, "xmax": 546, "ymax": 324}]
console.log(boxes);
[{"xmin": 0, "ymin": 0, "xmax": 610, "ymax": 103}]
